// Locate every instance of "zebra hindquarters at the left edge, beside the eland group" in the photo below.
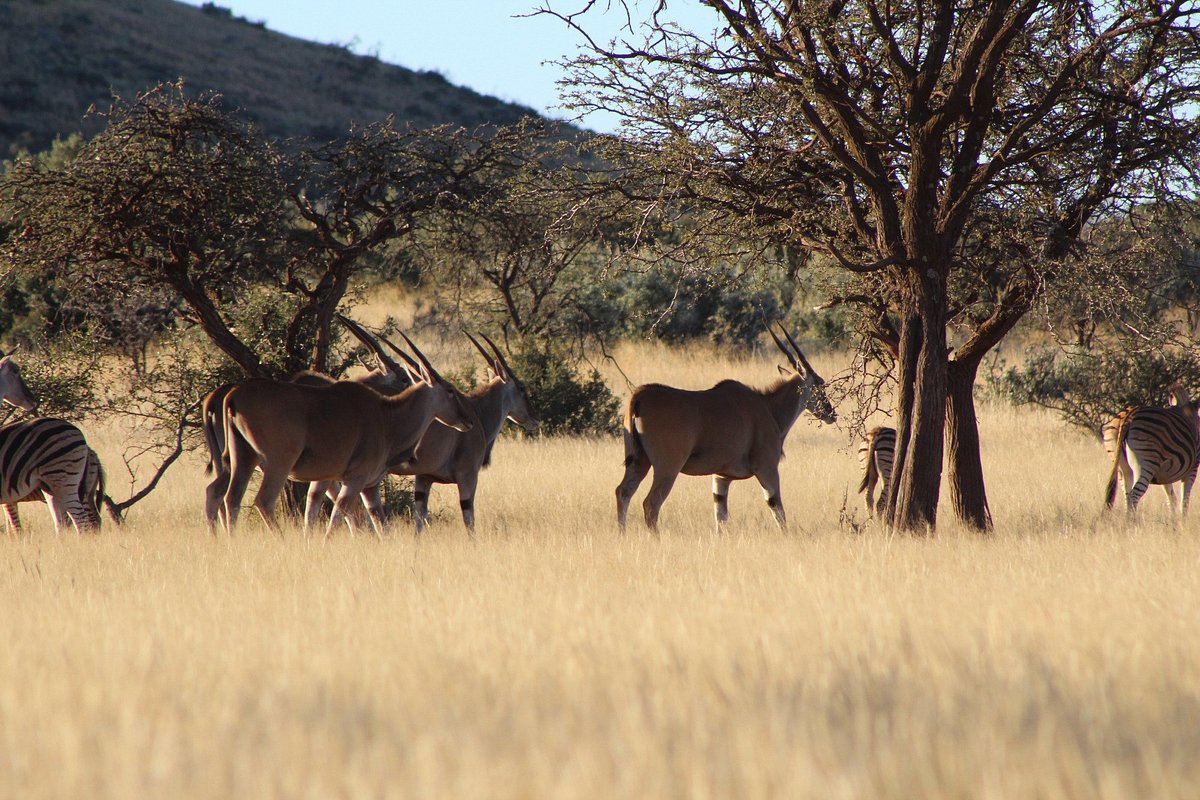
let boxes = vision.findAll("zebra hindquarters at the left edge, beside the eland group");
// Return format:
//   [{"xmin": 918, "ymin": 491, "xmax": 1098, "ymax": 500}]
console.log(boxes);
[{"xmin": 0, "ymin": 416, "xmax": 100, "ymax": 533}]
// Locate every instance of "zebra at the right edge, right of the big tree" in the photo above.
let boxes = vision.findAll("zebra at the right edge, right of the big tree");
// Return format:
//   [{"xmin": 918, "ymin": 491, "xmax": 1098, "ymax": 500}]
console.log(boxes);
[{"xmin": 1100, "ymin": 384, "xmax": 1200, "ymax": 516}]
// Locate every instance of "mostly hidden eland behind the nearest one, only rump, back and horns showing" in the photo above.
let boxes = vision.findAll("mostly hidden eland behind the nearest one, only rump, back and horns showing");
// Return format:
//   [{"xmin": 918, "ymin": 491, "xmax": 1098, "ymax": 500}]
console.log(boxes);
[{"xmin": 200, "ymin": 314, "xmax": 413, "ymax": 533}]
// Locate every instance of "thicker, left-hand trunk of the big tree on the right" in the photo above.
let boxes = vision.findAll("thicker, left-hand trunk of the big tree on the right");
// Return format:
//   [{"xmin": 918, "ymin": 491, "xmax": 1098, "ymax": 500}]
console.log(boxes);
[{"xmin": 889, "ymin": 261, "xmax": 947, "ymax": 533}]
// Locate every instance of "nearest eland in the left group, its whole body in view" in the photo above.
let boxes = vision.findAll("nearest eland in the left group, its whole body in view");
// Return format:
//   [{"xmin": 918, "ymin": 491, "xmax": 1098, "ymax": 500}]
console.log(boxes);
[{"xmin": 216, "ymin": 333, "xmax": 474, "ymax": 536}]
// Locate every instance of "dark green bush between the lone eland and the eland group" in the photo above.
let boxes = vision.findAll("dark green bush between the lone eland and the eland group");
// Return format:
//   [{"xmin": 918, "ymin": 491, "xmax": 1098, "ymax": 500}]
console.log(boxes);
[{"xmin": 509, "ymin": 341, "xmax": 619, "ymax": 435}]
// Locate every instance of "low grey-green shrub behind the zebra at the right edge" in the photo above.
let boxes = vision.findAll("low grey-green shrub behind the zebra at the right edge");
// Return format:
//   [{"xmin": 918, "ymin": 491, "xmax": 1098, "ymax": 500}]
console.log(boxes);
[{"xmin": 990, "ymin": 345, "xmax": 1200, "ymax": 435}]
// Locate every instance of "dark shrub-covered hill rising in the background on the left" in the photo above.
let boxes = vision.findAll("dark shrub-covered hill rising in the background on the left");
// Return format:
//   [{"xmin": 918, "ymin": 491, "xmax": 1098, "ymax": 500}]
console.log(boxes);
[{"xmin": 0, "ymin": 0, "xmax": 547, "ymax": 156}]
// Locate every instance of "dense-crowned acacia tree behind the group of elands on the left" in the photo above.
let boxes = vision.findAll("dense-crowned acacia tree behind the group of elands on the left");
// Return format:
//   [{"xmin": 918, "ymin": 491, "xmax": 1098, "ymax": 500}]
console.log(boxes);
[{"xmin": 0, "ymin": 84, "xmax": 544, "ymax": 375}]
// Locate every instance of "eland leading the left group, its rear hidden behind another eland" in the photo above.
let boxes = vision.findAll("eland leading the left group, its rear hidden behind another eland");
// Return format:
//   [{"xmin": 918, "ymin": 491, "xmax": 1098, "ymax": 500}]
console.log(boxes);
[{"xmin": 307, "ymin": 333, "xmax": 539, "ymax": 534}]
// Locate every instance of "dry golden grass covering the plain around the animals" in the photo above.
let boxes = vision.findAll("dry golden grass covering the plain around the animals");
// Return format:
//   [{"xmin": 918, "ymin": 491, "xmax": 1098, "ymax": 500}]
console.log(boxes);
[{"xmin": 0, "ymin": 335, "xmax": 1200, "ymax": 800}]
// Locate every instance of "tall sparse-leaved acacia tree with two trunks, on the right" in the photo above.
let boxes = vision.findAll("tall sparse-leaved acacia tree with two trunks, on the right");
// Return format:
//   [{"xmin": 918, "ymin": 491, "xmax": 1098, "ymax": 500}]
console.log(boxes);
[{"xmin": 542, "ymin": 0, "xmax": 1200, "ymax": 530}]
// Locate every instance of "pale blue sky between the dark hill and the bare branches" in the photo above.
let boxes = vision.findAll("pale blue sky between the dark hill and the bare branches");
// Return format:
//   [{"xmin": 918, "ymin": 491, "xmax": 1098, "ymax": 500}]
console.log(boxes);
[{"xmin": 178, "ymin": 0, "xmax": 713, "ymax": 131}]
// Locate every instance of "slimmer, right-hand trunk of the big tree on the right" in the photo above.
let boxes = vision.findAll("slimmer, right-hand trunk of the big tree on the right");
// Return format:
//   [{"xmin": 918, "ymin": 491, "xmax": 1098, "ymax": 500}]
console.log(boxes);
[{"xmin": 946, "ymin": 360, "xmax": 991, "ymax": 531}]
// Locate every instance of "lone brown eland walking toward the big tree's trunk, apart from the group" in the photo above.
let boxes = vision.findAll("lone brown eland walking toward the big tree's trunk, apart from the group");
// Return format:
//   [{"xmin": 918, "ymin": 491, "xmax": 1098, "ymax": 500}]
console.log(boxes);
[{"xmin": 617, "ymin": 327, "xmax": 838, "ymax": 531}]
